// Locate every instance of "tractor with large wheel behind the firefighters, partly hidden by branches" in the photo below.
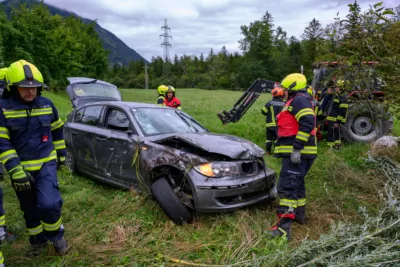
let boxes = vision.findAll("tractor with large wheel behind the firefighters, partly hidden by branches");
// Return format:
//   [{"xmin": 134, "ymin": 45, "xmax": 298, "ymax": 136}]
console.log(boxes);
[{"xmin": 311, "ymin": 61, "xmax": 393, "ymax": 143}]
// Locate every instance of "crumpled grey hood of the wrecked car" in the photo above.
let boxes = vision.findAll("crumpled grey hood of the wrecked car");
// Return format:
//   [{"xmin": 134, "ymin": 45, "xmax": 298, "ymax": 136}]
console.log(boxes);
[{"xmin": 148, "ymin": 132, "xmax": 265, "ymax": 159}]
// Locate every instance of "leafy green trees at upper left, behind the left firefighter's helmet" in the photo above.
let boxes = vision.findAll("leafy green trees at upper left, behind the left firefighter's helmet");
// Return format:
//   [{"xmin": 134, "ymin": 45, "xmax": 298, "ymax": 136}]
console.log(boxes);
[{"xmin": 0, "ymin": 3, "xmax": 108, "ymax": 89}]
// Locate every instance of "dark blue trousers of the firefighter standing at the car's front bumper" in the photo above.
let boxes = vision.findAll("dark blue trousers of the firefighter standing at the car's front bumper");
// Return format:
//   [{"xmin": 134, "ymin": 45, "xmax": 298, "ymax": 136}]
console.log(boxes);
[{"xmin": 277, "ymin": 156, "xmax": 314, "ymax": 219}]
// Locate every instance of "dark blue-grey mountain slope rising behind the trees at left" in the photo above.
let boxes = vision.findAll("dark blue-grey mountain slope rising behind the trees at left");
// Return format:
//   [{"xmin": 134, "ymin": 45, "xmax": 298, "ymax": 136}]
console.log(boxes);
[{"xmin": 0, "ymin": 0, "xmax": 149, "ymax": 65}]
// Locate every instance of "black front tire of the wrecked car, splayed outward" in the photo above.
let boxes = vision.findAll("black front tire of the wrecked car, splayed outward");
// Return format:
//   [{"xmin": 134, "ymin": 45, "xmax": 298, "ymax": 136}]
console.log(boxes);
[{"xmin": 151, "ymin": 178, "xmax": 193, "ymax": 225}]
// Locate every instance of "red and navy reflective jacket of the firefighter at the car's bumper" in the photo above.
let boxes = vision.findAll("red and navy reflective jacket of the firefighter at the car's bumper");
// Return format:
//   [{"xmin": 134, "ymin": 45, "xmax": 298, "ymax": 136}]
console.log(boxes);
[{"xmin": 274, "ymin": 92, "xmax": 317, "ymax": 159}]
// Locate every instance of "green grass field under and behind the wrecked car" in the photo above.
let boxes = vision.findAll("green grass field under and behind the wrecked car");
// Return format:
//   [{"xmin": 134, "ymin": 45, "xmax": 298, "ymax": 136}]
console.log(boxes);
[{"xmin": 1, "ymin": 89, "xmax": 400, "ymax": 267}]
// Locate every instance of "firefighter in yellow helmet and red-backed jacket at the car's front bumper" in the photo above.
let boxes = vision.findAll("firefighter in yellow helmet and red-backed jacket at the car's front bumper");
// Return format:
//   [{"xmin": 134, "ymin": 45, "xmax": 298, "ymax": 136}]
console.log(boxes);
[{"xmin": 269, "ymin": 73, "xmax": 317, "ymax": 240}]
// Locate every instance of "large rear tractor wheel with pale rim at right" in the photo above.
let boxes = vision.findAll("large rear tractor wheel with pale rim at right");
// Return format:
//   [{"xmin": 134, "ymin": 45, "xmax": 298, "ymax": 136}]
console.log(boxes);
[{"xmin": 341, "ymin": 101, "xmax": 393, "ymax": 143}]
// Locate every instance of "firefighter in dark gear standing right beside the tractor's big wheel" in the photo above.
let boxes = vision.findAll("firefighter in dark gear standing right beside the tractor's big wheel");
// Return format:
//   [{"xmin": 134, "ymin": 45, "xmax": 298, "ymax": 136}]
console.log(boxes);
[{"xmin": 326, "ymin": 80, "xmax": 349, "ymax": 150}]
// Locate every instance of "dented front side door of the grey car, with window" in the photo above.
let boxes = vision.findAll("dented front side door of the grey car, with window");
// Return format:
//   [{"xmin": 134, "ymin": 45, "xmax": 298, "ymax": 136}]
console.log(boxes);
[{"xmin": 95, "ymin": 107, "xmax": 139, "ymax": 188}]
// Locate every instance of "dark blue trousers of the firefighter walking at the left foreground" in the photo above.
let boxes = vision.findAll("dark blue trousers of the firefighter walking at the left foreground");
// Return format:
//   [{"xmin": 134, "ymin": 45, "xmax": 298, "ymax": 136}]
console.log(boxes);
[{"xmin": 16, "ymin": 160, "xmax": 64, "ymax": 245}]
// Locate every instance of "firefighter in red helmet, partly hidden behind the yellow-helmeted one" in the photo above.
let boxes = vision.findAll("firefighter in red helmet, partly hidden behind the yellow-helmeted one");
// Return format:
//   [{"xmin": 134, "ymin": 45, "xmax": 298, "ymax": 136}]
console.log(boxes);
[{"xmin": 261, "ymin": 87, "xmax": 285, "ymax": 155}]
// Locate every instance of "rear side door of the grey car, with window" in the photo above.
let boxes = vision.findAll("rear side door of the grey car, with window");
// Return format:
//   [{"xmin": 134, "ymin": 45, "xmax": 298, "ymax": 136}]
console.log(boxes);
[{"xmin": 70, "ymin": 105, "xmax": 104, "ymax": 175}]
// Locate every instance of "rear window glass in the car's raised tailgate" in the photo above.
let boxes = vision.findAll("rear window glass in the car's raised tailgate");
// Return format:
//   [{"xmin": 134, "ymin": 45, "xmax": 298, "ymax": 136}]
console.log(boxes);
[{"xmin": 74, "ymin": 83, "xmax": 121, "ymax": 100}]
